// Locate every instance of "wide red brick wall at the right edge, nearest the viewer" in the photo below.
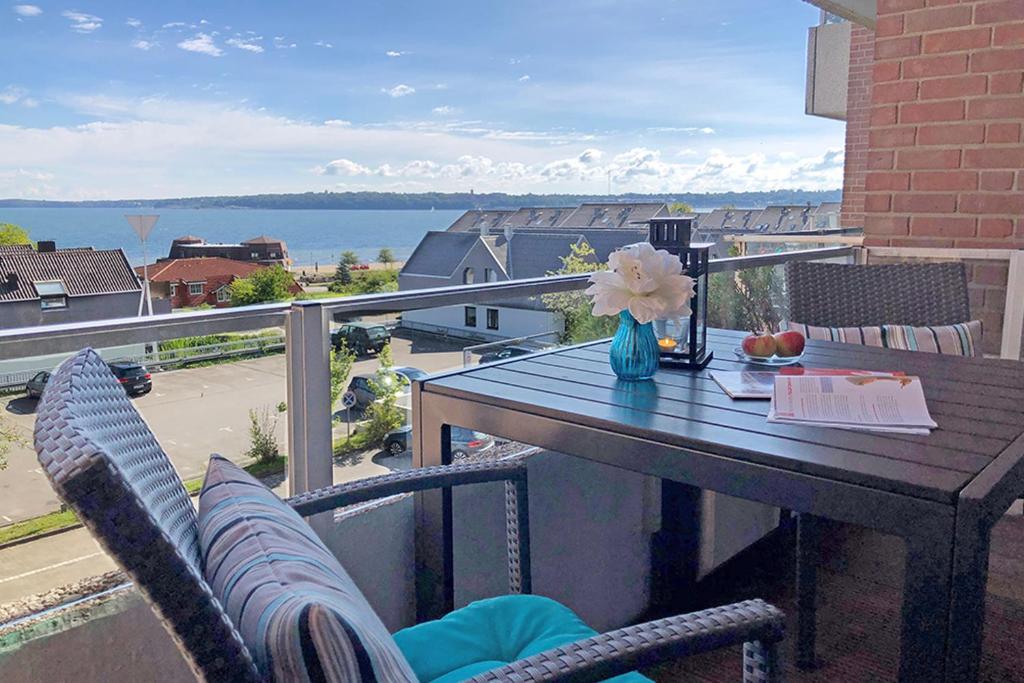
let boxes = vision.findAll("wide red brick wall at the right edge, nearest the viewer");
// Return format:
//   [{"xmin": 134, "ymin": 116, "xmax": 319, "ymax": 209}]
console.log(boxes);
[{"xmin": 863, "ymin": 0, "xmax": 1024, "ymax": 351}]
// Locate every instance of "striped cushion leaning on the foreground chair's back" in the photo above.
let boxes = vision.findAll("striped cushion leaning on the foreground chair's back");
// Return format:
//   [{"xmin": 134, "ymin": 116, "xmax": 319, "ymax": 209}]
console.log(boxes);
[{"xmin": 199, "ymin": 456, "xmax": 416, "ymax": 683}]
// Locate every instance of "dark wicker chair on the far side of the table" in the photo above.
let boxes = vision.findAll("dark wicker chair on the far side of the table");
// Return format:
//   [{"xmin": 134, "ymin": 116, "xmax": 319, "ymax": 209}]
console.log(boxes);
[{"xmin": 785, "ymin": 261, "xmax": 971, "ymax": 669}]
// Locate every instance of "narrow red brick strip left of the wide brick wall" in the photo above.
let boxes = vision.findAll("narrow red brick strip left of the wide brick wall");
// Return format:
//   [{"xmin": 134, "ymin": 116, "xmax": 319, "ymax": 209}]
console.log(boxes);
[{"xmin": 840, "ymin": 25, "xmax": 874, "ymax": 227}]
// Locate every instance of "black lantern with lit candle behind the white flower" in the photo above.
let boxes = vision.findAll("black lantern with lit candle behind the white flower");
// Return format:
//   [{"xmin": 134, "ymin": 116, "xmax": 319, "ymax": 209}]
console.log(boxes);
[{"xmin": 647, "ymin": 218, "xmax": 712, "ymax": 370}]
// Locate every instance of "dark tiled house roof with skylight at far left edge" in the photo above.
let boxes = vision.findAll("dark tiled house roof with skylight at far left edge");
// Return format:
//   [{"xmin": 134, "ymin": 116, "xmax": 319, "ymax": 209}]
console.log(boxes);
[{"xmin": 0, "ymin": 244, "xmax": 141, "ymax": 301}]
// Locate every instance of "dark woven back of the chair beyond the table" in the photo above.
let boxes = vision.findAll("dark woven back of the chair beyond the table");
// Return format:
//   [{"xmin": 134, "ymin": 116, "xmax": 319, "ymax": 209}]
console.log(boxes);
[{"xmin": 785, "ymin": 261, "xmax": 971, "ymax": 328}]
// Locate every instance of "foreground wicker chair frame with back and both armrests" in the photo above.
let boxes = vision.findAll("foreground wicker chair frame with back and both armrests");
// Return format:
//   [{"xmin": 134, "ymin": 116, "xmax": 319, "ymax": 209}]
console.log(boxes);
[{"xmin": 35, "ymin": 349, "xmax": 783, "ymax": 683}]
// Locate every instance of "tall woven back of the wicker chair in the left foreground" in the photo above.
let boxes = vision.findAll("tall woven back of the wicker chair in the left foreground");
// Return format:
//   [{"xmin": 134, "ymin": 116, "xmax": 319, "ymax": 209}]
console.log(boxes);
[{"xmin": 35, "ymin": 349, "xmax": 259, "ymax": 681}]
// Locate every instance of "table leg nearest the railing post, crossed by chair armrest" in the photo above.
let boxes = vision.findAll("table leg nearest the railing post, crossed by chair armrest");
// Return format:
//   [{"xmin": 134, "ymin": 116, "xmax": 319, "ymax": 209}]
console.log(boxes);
[{"xmin": 413, "ymin": 387, "xmax": 455, "ymax": 623}]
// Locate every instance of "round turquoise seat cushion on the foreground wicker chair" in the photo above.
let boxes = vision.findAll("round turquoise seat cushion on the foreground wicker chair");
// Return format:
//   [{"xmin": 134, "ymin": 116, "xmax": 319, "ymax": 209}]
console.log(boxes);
[{"xmin": 394, "ymin": 595, "xmax": 649, "ymax": 683}]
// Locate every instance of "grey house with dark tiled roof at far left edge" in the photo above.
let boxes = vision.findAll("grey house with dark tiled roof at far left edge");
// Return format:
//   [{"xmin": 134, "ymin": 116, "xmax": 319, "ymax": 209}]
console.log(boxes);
[{"xmin": 0, "ymin": 241, "xmax": 151, "ymax": 329}]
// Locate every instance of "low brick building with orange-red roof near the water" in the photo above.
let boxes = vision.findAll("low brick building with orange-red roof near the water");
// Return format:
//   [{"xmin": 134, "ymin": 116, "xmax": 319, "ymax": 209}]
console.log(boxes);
[{"xmin": 135, "ymin": 256, "xmax": 302, "ymax": 308}]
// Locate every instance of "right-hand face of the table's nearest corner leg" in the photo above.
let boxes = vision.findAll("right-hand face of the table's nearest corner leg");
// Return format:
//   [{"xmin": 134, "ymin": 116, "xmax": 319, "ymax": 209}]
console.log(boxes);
[{"xmin": 946, "ymin": 504, "xmax": 991, "ymax": 683}]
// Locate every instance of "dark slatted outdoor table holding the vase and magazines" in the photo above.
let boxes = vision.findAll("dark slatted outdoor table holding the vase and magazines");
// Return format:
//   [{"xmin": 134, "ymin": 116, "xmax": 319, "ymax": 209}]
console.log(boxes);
[{"xmin": 413, "ymin": 330, "xmax": 1024, "ymax": 682}]
